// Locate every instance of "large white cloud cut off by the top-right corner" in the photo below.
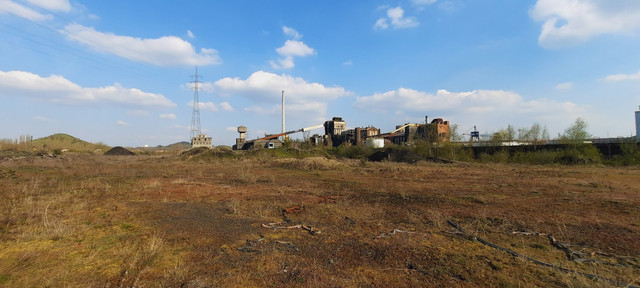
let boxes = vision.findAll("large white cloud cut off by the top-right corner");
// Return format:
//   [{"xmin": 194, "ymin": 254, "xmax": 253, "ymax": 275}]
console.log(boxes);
[{"xmin": 530, "ymin": 0, "xmax": 640, "ymax": 48}]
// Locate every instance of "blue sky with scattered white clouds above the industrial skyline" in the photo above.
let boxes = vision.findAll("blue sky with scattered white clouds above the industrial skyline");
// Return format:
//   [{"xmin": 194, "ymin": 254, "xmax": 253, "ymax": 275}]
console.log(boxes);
[{"xmin": 0, "ymin": 0, "xmax": 640, "ymax": 146}]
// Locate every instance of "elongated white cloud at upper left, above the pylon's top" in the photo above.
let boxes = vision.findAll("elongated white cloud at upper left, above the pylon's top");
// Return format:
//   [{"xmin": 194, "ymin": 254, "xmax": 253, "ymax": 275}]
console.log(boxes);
[{"xmin": 61, "ymin": 24, "xmax": 221, "ymax": 66}]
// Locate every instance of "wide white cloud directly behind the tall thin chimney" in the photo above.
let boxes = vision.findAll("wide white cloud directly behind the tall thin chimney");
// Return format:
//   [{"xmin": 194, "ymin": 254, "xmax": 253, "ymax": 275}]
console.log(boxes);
[{"xmin": 214, "ymin": 71, "xmax": 352, "ymax": 120}]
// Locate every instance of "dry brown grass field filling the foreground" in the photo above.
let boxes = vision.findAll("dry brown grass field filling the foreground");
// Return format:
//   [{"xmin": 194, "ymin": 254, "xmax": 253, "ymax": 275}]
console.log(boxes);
[{"xmin": 0, "ymin": 153, "xmax": 640, "ymax": 287}]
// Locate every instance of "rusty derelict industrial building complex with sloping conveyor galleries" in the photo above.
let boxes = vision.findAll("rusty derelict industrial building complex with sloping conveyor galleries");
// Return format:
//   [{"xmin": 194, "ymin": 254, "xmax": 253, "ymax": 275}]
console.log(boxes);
[{"xmin": 233, "ymin": 117, "xmax": 450, "ymax": 150}]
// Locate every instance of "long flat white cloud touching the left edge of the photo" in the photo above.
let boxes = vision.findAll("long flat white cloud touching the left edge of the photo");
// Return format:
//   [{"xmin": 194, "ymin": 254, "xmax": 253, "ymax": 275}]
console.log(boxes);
[{"xmin": 0, "ymin": 71, "xmax": 175, "ymax": 107}]
